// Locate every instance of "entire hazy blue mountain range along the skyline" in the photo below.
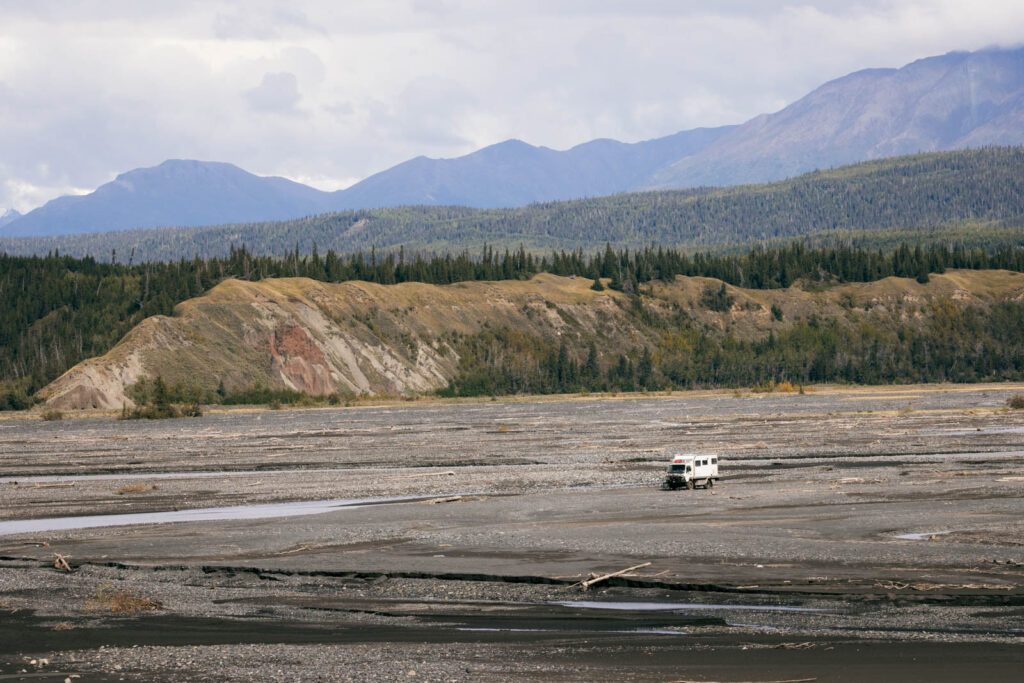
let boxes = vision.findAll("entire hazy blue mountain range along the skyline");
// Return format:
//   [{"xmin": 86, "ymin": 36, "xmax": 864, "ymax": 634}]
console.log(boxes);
[{"xmin": 0, "ymin": 48, "xmax": 1024, "ymax": 237}]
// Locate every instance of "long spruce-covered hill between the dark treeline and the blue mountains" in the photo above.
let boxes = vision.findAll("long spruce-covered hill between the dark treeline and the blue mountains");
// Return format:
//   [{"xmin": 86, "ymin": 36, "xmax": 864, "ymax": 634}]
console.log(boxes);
[{"xmin": 6, "ymin": 147, "xmax": 1024, "ymax": 261}]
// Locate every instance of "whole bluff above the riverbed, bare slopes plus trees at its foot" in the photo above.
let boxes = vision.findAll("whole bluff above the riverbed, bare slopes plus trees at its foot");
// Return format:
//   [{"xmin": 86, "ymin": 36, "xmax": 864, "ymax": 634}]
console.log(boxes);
[{"xmin": 41, "ymin": 270, "xmax": 1024, "ymax": 412}]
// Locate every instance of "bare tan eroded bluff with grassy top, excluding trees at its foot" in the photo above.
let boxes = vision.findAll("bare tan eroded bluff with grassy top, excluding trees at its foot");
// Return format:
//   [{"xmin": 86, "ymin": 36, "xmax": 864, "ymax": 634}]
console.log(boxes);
[{"xmin": 40, "ymin": 271, "xmax": 1024, "ymax": 410}]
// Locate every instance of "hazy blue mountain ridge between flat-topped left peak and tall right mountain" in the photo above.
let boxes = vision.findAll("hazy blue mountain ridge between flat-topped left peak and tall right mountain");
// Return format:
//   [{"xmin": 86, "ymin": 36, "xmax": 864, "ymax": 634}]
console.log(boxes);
[{"xmin": 336, "ymin": 126, "xmax": 733, "ymax": 209}]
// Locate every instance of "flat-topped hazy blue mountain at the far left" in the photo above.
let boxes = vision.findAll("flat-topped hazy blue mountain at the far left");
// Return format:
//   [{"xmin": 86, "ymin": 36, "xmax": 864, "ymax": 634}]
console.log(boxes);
[{"xmin": 2, "ymin": 160, "xmax": 339, "ymax": 237}]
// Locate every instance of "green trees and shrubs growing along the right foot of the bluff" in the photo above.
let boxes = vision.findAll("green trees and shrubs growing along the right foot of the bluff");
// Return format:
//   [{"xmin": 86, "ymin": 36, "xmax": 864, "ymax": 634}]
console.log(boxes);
[{"xmin": 440, "ymin": 299, "xmax": 1024, "ymax": 396}]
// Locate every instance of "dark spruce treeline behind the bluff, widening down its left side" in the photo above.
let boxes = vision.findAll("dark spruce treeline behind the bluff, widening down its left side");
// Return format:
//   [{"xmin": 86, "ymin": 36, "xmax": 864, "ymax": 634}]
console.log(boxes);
[{"xmin": 0, "ymin": 243, "xmax": 1024, "ymax": 409}]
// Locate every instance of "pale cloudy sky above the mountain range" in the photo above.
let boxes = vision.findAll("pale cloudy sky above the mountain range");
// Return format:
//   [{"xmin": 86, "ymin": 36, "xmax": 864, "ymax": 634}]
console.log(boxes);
[{"xmin": 0, "ymin": 0, "xmax": 1024, "ymax": 213}]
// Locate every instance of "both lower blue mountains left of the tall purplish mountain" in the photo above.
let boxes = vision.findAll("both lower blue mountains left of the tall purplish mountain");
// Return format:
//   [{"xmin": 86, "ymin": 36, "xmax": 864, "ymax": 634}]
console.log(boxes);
[{"xmin": 0, "ymin": 127, "xmax": 729, "ymax": 237}]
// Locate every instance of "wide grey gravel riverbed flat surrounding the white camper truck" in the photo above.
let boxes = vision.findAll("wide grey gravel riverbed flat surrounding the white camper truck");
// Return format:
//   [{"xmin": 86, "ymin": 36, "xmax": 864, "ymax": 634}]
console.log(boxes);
[{"xmin": 0, "ymin": 385, "xmax": 1024, "ymax": 681}]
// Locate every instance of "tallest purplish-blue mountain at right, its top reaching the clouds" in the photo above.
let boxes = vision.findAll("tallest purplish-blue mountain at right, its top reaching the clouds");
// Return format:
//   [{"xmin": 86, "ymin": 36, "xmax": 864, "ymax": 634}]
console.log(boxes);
[{"xmin": 646, "ymin": 48, "xmax": 1024, "ymax": 187}]
